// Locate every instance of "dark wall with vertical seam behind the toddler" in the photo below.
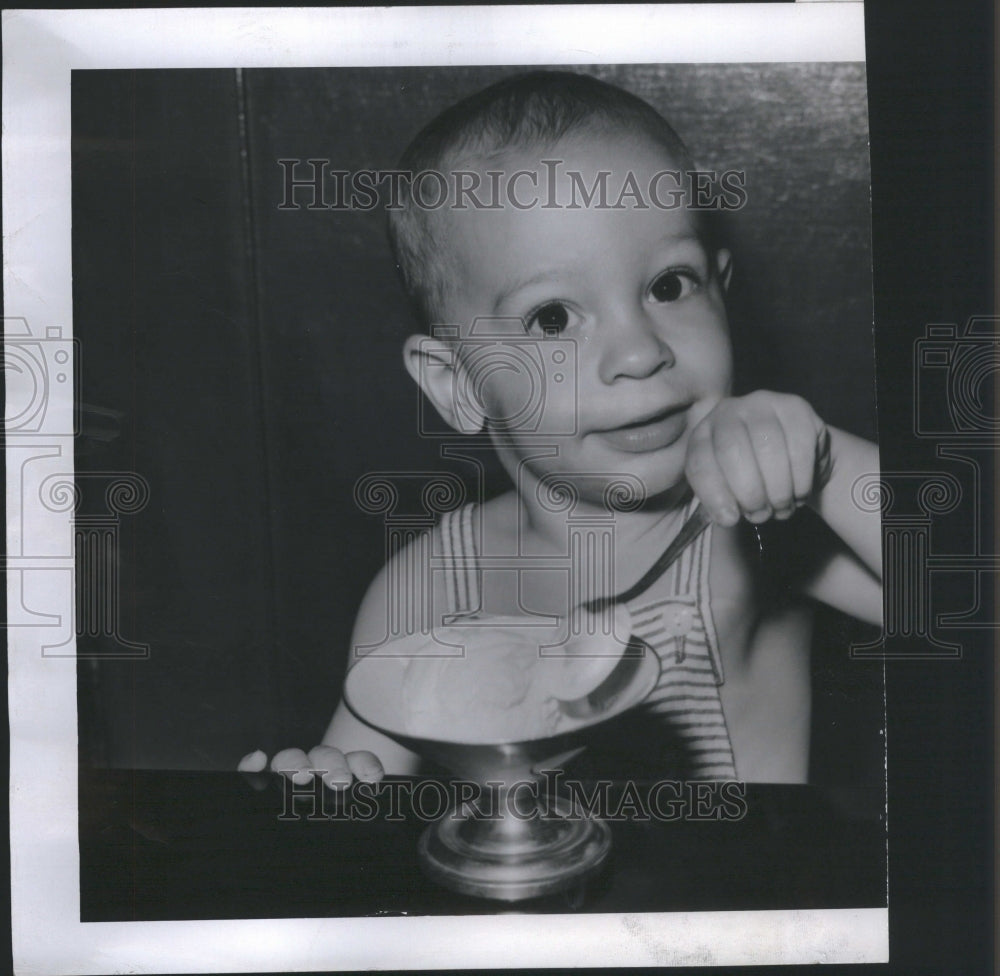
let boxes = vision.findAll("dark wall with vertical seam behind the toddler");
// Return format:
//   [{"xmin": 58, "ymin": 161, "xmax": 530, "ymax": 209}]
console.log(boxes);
[{"xmin": 73, "ymin": 64, "xmax": 881, "ymax": 778}]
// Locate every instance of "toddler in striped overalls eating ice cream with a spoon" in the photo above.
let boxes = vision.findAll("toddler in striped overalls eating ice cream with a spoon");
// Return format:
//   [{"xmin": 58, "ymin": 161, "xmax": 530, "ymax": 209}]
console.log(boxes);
[{"xmin": 241, "ymin": 72, "xmax": 882, "ymax": 786}]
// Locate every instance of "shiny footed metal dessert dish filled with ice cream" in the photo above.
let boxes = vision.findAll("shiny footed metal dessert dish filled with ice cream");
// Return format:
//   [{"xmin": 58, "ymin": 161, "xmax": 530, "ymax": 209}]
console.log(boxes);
[{"xmin": 344, "ymin": 605, "xmax": 660, "ymax": 901}]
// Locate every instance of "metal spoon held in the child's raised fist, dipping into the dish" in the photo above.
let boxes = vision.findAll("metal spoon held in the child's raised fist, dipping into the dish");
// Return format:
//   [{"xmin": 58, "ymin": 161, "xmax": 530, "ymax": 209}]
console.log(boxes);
[{"xmin": 557, "ymin": 504, "xmax": 711, "ymax": 719}]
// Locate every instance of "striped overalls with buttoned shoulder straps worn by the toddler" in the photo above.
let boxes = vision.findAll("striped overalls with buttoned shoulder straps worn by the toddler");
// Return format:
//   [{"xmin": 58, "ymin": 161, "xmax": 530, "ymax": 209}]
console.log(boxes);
[{"xmin": 441, "ymin": 499, "xmax": 736, "ymax": 780}]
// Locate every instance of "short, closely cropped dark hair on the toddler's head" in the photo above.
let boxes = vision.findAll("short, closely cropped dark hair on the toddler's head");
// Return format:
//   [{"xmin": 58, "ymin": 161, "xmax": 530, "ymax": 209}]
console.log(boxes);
[{"xmin": 388, "ymin": 71, "xmax": 694, "ymax": 328}]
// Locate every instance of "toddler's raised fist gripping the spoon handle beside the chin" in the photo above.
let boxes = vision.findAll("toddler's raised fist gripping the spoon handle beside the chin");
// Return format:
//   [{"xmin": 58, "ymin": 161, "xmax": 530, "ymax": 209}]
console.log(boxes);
[{"xmin": 685, "ymin": 390, "xmax": 830, "ymax": 525}]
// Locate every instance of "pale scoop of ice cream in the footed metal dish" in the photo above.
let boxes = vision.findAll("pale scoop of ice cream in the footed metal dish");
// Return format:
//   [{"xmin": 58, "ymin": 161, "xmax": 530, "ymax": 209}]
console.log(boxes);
[{"xmin": 401, "ymin": 607, "xmax": 630, "ymax": 743}]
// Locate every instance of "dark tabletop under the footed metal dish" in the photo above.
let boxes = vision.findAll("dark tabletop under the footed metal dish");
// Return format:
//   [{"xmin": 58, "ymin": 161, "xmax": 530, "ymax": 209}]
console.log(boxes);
[{"xmin": 80, "ymin": 769, "xmax": 886, "ymax": 922}]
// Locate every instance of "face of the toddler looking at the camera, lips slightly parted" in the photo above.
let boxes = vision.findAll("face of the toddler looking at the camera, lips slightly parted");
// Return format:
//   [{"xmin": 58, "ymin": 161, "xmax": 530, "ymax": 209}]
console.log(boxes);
[{"xmin": 444, "ymin": 135, "xmax": 732, "ymax": 497}]
